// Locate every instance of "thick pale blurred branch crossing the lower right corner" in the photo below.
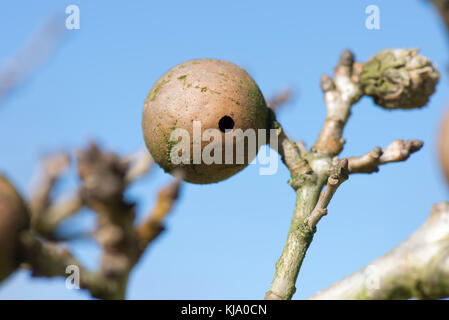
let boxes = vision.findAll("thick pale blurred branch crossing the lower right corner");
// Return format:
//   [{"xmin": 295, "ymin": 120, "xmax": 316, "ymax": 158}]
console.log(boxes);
[{"xmin": 310, "ymin": 202, "xmax": 449, "ymax": 299}]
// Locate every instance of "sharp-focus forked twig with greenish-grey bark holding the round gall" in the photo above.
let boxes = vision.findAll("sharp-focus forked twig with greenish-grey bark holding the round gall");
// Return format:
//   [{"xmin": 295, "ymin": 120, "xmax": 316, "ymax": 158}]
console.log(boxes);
[{"xmin": 265, "ymin": 50, "xmax": 428, "ymax": 299}]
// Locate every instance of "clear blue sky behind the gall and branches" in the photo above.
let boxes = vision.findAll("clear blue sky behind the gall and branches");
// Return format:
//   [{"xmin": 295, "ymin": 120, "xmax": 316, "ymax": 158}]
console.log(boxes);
[{"xmin": 0, "ymin": 0, "xmax": 449, "ymax": 299}]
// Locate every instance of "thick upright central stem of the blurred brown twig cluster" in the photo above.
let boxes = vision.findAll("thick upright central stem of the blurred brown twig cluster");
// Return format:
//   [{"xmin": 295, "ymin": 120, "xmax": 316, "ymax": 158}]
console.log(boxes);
[{"xmin": 77, "ymin": 144, "xmax": 138, "ymax": 299}]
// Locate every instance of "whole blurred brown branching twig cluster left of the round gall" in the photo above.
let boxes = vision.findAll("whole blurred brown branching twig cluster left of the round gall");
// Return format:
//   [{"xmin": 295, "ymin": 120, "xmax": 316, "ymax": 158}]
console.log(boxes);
[{"xmin": 10, "ymin": 143, "xmax": 166, "ymax": 299}]
